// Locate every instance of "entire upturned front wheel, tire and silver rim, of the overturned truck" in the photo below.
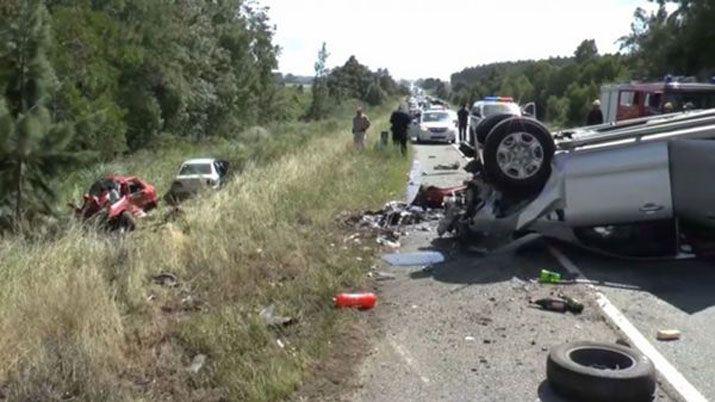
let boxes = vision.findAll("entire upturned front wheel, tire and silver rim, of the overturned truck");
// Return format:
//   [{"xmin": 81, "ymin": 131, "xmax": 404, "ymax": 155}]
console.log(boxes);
[{"xmin": 484, "ymin": 117, "xmax": 556, "ymax": 197}]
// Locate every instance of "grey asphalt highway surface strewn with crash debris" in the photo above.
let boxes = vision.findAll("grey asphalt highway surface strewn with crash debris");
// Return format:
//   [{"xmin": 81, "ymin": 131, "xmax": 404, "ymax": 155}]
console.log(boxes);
[{"xmin": 350, "ymin": 145, "xmax": 684, "ymax": 401}]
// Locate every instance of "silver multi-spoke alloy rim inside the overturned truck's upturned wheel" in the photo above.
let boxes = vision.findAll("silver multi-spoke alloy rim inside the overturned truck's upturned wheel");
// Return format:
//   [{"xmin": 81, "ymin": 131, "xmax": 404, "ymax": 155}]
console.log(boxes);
[{"xmin": 497, "ymin": 132, "xmax": 544, "ymax": 179}]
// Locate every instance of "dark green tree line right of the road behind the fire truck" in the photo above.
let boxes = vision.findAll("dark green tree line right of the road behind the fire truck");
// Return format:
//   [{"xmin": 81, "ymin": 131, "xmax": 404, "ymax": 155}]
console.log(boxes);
[{"xmin": 442, "ymin": 0, "xmax": 715, "ymax": 126}]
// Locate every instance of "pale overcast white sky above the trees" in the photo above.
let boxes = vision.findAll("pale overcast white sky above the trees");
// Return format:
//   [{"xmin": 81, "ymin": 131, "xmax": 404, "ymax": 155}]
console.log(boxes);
[{"xmin": 258, "ymin": 0, "xmax": 652, "ymax": 80}]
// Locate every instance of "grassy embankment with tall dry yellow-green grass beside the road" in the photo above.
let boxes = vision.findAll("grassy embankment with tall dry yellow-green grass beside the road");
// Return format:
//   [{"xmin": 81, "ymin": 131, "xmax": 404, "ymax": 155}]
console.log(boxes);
[{"xmin": 0, "ymin": 102, "xmax": 409, "ymax": 401}]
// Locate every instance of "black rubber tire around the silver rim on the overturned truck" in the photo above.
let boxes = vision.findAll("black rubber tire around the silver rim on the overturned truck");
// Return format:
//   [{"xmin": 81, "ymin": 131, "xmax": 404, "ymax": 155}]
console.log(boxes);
[{"xmin": 483, "ymin": 117, "xmax": 556, "ymax": 197}]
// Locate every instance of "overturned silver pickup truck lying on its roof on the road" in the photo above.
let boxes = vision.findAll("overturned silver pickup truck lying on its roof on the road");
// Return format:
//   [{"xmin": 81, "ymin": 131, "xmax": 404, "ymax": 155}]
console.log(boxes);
[{"xmin": 440, "ymin": 109, "xmax": 715, "ymax": 257}]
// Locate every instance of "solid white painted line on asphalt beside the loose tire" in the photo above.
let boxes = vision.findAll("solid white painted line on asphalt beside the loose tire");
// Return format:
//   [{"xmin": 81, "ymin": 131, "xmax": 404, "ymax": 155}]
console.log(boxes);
[{"xmin": 549, "ymin": 246, "xmax": 707, "ymax": 402}]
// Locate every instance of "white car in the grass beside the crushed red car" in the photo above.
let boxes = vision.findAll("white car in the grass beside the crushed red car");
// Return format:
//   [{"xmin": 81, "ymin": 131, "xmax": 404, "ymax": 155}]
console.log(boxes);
[{"xmin": 166, "ymin": 158, "xmax": 229, "ymax": 201}]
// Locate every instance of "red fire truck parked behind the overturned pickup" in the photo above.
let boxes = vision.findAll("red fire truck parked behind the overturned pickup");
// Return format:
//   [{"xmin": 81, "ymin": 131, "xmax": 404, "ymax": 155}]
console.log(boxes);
[{"xmin": 601, "ymin": 81, "xmax": 715, "ymax": 123}]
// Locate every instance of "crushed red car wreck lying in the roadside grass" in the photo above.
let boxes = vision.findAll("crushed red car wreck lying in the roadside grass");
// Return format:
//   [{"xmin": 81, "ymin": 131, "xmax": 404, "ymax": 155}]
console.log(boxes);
[{"xmin": 70, "ymin": 176, "xmax": 159, "ymax": 231}]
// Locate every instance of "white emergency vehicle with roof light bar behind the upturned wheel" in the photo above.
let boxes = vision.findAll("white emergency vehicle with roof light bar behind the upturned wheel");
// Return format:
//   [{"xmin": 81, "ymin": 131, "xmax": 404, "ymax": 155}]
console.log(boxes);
[{"xmin": 468, "ymin": 96, "xmax": 536, "ymax": 149}]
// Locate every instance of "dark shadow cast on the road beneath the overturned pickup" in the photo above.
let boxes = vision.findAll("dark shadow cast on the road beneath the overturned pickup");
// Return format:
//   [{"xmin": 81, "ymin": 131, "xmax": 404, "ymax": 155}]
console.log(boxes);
[{"xmin": 411, "ymin": 234, "xmax": 715, "ymax": 314}]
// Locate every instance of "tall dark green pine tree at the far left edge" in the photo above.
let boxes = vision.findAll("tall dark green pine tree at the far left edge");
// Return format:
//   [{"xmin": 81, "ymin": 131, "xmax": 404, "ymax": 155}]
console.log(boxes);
[{"xmin": 0, "ymin": 0, "xmax": 76, "ymax": 222}]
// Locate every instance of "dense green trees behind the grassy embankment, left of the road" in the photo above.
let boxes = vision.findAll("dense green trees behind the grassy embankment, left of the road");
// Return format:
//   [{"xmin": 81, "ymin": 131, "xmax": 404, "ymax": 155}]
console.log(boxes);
[{"xmin": 0, "ymin": 0, "xmax": 402, "ymax": 224}]
